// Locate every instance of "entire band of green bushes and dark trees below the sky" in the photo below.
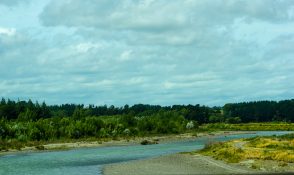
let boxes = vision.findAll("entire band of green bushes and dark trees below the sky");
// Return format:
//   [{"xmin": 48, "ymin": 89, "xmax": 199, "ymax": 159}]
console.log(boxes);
[{"xmin": 0, "ymin": 98, "xmax": 294, "ymax": 149}]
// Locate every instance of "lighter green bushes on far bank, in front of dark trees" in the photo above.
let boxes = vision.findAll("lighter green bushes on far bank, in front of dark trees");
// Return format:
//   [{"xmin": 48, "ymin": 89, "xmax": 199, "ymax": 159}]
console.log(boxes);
[{"xmin": 0, "ymin": 111, "xmax": 193, "ymax": 150}]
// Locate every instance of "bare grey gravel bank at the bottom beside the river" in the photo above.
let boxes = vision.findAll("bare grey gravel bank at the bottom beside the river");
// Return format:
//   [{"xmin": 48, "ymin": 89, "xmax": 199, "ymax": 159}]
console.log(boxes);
[{"xmin": 103, "ymin": 154, "xmax": 256, "ymax": 175}]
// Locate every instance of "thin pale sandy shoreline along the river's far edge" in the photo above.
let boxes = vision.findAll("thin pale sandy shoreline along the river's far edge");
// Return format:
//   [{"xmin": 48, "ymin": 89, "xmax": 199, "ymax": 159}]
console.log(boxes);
[{"xmin": 0, "ymin": 131, "xmax": 254, "ymax": 156}]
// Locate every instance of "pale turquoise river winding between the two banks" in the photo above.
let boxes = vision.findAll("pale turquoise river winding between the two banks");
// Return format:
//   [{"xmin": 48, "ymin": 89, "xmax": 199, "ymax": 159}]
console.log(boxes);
[{"xmin": 0, "ymin": 131, "xmax": 289, "ymax": 175}]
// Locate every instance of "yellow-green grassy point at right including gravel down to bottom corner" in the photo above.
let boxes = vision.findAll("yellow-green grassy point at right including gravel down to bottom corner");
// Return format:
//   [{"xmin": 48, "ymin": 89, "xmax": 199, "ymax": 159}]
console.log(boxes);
[{"xmin": 195, "ymin": 134, "xmax": 294, "ymax": 173}]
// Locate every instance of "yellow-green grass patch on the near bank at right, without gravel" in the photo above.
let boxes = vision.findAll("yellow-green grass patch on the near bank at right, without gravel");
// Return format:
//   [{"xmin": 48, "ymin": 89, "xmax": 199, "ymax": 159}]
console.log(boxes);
[{"xmin": 199, "ymin": 134, "xmax": 294, "ymax": 165}]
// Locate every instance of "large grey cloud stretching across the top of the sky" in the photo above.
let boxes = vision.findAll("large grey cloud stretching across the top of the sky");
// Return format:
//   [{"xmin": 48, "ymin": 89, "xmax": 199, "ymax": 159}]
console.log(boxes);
[{"xmin": 41, "ymin": 0, "xmax": 294, "ymax": 28}]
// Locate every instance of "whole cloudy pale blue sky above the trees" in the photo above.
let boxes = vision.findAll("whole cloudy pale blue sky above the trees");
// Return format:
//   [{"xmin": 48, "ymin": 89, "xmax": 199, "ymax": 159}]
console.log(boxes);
[{"xmin": 0, "ymin": 0, "xmax": 294, "ymax": 106}]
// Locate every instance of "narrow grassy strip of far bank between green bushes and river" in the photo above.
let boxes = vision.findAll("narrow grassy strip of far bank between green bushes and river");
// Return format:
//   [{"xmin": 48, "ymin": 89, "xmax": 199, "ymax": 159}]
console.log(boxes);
[{"xmin": 0, "ymin": 132, "xmax": 201, "ymax": 156}]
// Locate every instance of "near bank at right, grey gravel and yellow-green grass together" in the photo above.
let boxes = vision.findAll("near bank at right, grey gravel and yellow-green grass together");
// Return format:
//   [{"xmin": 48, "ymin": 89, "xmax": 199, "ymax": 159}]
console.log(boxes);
[{"xmin": 103, "ymin": 134, "xmax": 294, "ymax": 175}]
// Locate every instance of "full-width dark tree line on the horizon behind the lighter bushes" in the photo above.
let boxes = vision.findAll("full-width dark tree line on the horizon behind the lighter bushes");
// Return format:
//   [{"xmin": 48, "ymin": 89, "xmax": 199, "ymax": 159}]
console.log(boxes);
[{"xmin": 0, "ymin": 98, "xmax": 294, "ymax": 124}]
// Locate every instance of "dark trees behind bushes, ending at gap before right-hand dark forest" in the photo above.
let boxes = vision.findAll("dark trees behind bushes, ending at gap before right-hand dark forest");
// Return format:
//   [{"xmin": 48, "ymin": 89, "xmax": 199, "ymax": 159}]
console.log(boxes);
[{"xmin": 0, "ymin": 98, "xmax": 212, "ymax": 123}]
